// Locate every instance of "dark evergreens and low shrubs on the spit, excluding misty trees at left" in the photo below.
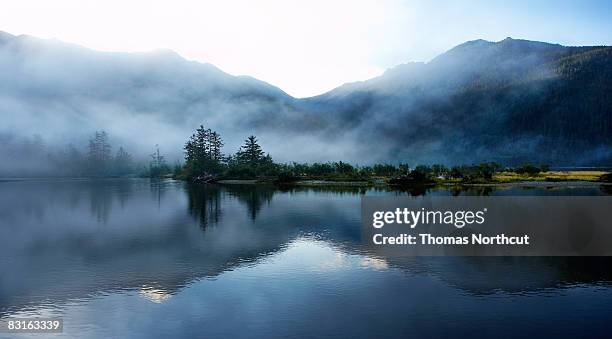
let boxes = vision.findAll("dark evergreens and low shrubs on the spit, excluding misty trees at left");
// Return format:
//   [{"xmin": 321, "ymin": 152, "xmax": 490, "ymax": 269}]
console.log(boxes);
[{"xmin": 176, "ymin": 125, "xmax": 548, "ymax": 185}]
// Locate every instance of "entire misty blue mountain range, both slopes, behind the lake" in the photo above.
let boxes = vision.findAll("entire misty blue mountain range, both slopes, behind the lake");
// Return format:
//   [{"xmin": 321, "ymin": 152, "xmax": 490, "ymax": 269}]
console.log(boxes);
[{"xmin": 0, "ymin": 33, "xmax": 612, "ymax": 172}]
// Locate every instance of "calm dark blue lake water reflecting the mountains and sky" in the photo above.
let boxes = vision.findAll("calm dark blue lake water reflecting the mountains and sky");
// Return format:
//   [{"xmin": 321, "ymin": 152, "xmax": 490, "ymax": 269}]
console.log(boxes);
[{"xmin": 0, "ymin": 179, "xmax": 612, "ymax": 338}]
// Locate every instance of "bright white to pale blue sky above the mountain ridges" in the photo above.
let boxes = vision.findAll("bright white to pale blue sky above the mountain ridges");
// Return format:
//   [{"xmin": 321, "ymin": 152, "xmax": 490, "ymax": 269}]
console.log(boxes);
[{"xmin": 0, "ymin": 0, "xmax": 612, "ymax": 97}]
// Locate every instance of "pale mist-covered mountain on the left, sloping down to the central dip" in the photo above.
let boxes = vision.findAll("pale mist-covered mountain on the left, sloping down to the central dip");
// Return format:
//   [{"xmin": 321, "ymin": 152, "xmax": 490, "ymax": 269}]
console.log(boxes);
[{"xmin": 0, "ymin": 33, "xmax": 295, "ymax": 159}]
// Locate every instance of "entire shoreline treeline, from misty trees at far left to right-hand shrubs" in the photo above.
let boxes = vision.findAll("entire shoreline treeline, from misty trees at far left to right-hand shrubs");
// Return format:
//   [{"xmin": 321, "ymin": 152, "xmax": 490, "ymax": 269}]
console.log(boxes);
[{"xmin": 0, "ymin": 126, "xmax": 548, "ymax": 185}]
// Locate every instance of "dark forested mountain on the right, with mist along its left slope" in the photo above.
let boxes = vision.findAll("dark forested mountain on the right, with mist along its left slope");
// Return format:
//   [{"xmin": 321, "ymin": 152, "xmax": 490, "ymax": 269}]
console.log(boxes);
[{"xmin": 305, "ymin": 38, "xmax": 612, "ymax": 165}]
